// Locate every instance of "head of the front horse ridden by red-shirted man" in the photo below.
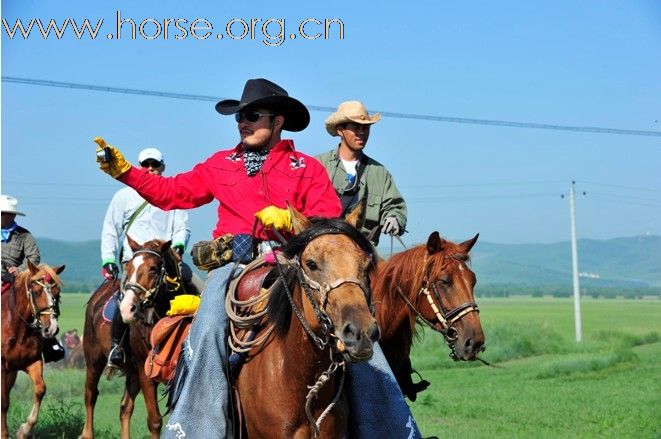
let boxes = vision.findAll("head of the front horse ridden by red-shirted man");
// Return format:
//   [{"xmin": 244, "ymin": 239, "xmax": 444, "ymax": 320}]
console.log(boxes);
[{"xmin": 269, "ymin": 207, "xmax": 380, "ymax": 361}]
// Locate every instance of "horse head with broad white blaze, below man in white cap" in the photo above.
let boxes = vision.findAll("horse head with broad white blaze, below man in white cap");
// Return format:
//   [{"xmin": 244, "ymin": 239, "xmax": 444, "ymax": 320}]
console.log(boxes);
[{"xmin": 119, "ymin": 236, "xmax": 181, "ymax": 324}]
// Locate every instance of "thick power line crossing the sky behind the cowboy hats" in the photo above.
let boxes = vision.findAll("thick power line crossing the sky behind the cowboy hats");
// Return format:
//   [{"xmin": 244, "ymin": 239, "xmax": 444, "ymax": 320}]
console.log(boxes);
[{"xmin": 2, "ymin": 76, "xmax": 661, "ymax": 137}]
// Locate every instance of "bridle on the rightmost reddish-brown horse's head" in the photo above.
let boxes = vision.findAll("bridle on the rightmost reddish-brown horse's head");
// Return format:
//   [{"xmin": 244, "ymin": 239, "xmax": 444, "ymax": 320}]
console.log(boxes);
[{"xmin": 397, "ymin": 256, "xmax": 480, "ymax": 361}]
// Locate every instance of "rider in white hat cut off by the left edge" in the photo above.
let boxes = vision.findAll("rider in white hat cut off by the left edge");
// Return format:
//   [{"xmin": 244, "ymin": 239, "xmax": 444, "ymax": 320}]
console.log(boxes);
[{"xmin": 0, "ymin": 195, "xmax": 64, "ymax": 363}]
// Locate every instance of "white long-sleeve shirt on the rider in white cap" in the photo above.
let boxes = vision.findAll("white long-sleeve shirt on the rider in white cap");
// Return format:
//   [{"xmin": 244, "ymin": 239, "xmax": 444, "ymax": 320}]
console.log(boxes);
[{"xmin": 101, "ymin": 187, "xmax": 190, "ymax": 264}]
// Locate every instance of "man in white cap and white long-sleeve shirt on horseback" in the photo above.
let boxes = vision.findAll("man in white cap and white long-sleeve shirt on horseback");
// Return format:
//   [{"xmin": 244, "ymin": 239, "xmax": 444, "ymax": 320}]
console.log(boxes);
[{"xmin": 101, "ymin": 148, "xmax": 203, "ymax": 369}]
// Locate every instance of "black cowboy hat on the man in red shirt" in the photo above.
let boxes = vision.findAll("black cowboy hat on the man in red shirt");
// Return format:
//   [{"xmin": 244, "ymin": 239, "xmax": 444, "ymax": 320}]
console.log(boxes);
[{"xmin": 216, "ymin": 78, "xmax": 310, "ymax": 131}]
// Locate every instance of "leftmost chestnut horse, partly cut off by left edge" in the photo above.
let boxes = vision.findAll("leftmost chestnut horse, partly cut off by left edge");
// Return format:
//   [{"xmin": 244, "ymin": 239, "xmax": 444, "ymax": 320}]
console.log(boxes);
[{"xmin": 2, "ymin": 260, "xmax": 64, "ymax": 439}]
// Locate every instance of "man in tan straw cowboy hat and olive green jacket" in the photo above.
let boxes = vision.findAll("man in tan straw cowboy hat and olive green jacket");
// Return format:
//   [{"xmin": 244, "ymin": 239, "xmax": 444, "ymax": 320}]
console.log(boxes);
[{"xmin": 317, "ymin": 101, "xmax": 406, "ymax": 245}]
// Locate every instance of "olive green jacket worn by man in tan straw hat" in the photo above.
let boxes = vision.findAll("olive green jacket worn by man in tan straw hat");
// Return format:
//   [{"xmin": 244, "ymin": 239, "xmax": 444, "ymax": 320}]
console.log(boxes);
[{"xmin": 316, "ymin": 148, "xmax": 406, "ymax": 245}]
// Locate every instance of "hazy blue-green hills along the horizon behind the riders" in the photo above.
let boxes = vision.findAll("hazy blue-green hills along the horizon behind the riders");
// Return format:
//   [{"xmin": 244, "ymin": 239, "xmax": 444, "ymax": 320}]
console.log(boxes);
[{"xmin": 38, "ymin": 236, "xmax": 661, "ymax": 291}]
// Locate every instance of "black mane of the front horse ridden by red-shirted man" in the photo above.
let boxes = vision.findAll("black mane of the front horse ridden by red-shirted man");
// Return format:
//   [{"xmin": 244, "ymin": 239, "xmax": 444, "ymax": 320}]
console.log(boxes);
[{"xmin": 268, "ymin": 218, "xmax": 375, "ymax": 334}]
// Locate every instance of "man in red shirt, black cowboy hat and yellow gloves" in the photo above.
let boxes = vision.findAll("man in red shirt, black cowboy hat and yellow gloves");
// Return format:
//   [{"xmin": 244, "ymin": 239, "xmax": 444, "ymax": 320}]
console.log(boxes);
[{"xmin": 95, "ymin": 79, "xmax": 422, "ymax": 438}]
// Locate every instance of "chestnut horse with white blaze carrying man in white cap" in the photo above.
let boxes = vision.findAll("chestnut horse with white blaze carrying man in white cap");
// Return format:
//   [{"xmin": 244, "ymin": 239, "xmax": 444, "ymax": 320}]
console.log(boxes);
[{"xmin": 79, "ymin": 237, "xmax": 183, "ymax": 439}]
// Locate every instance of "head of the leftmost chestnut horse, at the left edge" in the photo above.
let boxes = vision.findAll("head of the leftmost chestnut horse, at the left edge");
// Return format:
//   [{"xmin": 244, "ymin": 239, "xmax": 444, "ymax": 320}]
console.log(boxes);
[{"xmin": 22, "ymin": 260, "xmax": 64, "ymax": 338}]
